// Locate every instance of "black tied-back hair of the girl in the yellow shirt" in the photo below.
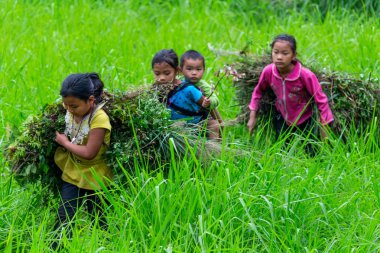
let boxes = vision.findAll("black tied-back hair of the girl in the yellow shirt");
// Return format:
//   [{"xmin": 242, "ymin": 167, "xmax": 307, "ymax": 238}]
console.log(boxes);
[{"xmin": 60, "ymin": 73, "xmax": 104, "ymax": 103}]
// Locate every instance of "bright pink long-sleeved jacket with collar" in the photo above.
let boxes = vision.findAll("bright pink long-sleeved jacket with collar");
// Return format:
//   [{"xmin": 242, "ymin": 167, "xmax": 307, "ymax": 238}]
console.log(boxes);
[{"xmin": 249, "ymin": 61, "xmax": 334, "ymax": 125}]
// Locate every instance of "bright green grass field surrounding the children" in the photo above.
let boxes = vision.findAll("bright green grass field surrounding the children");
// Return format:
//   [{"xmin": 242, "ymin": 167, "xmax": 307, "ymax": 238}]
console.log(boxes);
[{"xmin": 0, "ymin": 0, "xmax": 380, "ymax": 252}]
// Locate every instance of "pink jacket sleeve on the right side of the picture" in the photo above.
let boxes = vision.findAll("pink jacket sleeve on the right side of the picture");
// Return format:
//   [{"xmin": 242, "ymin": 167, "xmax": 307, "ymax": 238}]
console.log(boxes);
[{"xmin": 304, "ymin": 71, "xmax": 334, "ymax": 125}]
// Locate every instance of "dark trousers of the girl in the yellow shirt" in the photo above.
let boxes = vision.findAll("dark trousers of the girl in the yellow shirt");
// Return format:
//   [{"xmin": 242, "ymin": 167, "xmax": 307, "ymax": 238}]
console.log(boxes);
[{"xmin": 53, "ymin": 182, "xmax": 108, "ymax": 248}]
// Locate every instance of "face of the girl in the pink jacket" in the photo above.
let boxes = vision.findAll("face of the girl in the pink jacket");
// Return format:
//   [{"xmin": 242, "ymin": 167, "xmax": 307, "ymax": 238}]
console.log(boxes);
[{"xmin": 272, "ymin": 40, "xmax": 296, "ymax": 73}]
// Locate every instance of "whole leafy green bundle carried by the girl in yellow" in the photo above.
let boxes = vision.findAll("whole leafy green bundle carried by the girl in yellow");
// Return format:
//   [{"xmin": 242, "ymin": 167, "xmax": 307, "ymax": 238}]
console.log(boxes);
[{"xmin": 5, "ymin": 87, "xmax": 220, "ymax": 194}]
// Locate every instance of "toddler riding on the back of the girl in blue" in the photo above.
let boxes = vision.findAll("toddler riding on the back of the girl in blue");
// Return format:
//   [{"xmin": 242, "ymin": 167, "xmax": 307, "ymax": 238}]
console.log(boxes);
[{"xmin": 180, "ymin": 50, "xmax": 223, "ymax": 139}]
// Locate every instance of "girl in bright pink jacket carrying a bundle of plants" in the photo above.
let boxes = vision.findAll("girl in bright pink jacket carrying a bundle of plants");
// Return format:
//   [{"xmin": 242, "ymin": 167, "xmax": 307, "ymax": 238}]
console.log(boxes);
[{"xmin": 247, "ymin": 34, "xmax": 334, "ymax": 142}]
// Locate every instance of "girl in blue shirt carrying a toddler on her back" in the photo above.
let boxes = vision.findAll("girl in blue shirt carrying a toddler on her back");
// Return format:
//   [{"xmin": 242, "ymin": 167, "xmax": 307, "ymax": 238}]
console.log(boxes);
[{"xmin": 152, "ymin": 49, "xmax": 217, "ymax": 138}]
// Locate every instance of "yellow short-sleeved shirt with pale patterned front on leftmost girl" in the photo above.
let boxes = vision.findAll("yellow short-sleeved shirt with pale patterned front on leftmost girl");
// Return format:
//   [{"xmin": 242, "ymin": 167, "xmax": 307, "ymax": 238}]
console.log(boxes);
[{"xmin": 54, "ymin": 108, "xmax": 113, "ymax": 190}]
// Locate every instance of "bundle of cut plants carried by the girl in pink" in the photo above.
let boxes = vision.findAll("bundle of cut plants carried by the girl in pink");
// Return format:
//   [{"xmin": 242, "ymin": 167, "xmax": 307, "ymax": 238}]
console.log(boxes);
[{"xmin": 233, "ymin": 55, "xmax": 380, "ymax": 133}]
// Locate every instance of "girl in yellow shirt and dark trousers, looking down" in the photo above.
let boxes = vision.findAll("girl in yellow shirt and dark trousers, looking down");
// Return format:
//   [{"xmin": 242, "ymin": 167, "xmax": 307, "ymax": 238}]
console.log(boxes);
[{"xmin": 53, "ymin": 73, "xmax": 113, "ymax": 248}]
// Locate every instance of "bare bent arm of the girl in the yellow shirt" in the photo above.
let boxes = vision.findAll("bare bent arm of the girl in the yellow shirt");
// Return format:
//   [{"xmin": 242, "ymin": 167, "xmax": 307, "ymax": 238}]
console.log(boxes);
[{"xmin": 55, "ymin": 128, "xmax": 107, "ymax": 160}]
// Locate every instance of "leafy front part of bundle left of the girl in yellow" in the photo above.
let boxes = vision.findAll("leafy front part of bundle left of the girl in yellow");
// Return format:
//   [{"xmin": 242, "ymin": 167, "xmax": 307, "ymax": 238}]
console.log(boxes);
[{"xmin": 5, "ymin": 103, "xmax": 65, "ymax": 190}]
